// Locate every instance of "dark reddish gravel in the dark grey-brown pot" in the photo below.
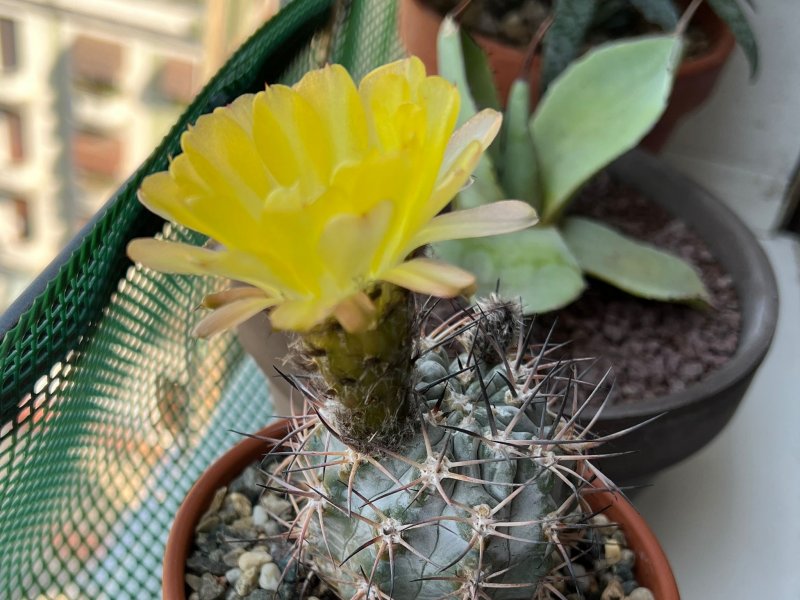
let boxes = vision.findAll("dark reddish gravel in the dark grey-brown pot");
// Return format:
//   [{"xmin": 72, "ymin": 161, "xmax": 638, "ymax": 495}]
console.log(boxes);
[{"xmin": 537, "ymin": 175, "xmax": 741, "ymax": 402}]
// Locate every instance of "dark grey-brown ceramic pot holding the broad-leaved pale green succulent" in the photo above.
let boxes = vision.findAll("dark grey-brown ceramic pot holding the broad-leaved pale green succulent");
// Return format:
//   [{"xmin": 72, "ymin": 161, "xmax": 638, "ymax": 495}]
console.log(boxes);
[{"xmin": 584, "ymin": 150, "xmax": 779, "ymax": 485}]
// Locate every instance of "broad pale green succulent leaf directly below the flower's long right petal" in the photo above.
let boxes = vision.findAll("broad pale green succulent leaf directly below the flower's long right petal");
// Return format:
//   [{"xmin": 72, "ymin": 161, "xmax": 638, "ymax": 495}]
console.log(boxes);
[{"xmin": 434, "ymin": 227, "xmax": 586, "ymax": 314}]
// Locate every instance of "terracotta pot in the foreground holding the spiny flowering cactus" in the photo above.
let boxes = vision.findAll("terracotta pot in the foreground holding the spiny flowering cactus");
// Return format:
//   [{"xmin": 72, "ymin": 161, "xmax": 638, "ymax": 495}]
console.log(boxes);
[{"xmin": 161, "ymin": 420, "xmax": 680, "ymax": 600}]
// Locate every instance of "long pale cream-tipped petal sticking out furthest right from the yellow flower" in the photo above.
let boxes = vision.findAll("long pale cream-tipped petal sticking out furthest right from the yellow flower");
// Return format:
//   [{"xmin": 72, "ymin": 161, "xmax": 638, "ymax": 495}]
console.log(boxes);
[{"xmin": 406, "ymin": 200, "xmax": 539, "ymax": 253}]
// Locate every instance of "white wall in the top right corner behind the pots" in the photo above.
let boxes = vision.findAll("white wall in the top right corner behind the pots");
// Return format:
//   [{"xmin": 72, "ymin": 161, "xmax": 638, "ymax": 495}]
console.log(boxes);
[{"xmin": 663, "ymin": 0, "xmax": 800, "ymax": 231}]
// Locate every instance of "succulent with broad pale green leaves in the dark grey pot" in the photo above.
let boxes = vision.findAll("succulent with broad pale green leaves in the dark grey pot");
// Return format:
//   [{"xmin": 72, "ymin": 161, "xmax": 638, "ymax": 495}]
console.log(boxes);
[{"xmin": 435, "ymin": 8, "xmax": 709, "ymax": 313}]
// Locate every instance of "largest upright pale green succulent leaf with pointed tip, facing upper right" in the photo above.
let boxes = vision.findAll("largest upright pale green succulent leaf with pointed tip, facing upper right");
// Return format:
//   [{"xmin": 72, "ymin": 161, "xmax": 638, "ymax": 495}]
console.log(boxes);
[{"xmin": 530, "ymin": 35, "xmax": 682, "ymax": 222}]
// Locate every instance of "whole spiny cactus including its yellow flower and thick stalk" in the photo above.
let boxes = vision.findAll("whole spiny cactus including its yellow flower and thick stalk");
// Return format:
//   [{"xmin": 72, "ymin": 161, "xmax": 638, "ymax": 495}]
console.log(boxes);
[{"xmin": 129, "ymin": 58, "xmax": 620, "ymax": 600}]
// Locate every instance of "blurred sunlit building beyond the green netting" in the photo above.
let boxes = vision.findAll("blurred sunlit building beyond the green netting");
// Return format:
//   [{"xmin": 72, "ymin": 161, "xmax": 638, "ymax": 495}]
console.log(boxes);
[{"xmin": 0, "ymin": 0, "xmax": 278, "ymax": 312}]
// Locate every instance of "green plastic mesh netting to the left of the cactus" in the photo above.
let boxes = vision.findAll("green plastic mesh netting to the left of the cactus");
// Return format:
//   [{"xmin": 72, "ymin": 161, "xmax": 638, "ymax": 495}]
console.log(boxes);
[{"xmin": 0, "ymin": 0, "xmax": 400, "ymax": 599}]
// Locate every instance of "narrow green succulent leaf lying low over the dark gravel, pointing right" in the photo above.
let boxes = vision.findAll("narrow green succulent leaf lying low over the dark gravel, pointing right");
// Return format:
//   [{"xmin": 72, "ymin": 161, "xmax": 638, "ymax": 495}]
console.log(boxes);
[{"xmin": 562, "ymin": 217, "xmax": 709, "ymax": 304}]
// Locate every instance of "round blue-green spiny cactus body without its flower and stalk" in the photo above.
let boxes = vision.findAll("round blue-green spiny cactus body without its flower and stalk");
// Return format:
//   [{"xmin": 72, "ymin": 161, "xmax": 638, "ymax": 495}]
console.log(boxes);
[{"xmin": 273, "ymin": 298, "xmax": 612, "ymax": 599}]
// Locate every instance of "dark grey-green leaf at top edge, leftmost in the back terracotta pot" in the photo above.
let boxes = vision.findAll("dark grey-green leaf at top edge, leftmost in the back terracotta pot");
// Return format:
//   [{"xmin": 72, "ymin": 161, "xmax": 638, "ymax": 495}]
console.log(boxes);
[{"xmin": 540, "ymin": 0, "xmax": 597, "ymax": 91}]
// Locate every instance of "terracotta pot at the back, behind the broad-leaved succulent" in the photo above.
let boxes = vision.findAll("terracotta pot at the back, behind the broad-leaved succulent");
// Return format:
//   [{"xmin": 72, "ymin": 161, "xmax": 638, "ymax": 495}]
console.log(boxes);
[{"xmin": 399, "ymin": 0, "xmax": 735, "ymax": 151}]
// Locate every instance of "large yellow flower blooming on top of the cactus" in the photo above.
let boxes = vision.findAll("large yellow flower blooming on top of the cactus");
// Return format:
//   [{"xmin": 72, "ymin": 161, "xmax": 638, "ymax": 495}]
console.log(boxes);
[{"xmin": 128, "ymin": 58, "xmax": 536, "ymax": 336}]
